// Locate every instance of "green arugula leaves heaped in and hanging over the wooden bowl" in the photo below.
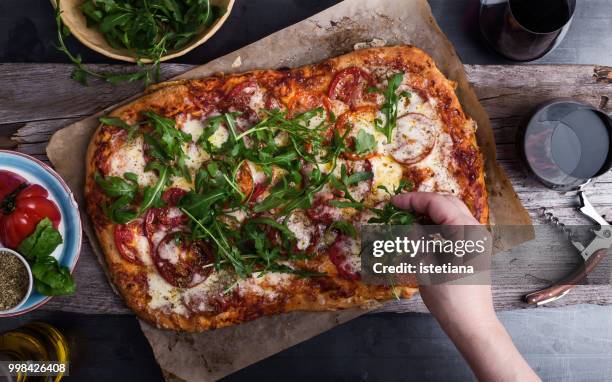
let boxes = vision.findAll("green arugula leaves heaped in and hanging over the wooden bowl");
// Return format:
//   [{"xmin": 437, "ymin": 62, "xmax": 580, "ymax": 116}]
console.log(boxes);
[{"xmin": 55, "ymin": 0, "xmax": 225, "ymax": 86}]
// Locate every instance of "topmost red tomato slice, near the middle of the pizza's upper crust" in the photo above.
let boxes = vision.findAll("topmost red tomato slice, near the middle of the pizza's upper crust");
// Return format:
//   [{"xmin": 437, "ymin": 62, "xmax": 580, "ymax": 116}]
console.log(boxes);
[{"xmin": 327, "ymin": 67, "xmax": 373, "ymax": 108}]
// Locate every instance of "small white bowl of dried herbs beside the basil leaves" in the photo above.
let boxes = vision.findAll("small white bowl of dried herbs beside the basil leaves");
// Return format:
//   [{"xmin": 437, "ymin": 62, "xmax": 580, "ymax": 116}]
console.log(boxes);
[{"xmin": 0, "ymin": 248, "xmax": 33, "ymax": 317}]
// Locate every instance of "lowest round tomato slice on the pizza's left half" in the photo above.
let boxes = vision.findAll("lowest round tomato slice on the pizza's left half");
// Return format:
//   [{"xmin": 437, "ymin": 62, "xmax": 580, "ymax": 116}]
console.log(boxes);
[{"xmin": 153, "ymin": 232, "xmax": 214, "ymax": 288}]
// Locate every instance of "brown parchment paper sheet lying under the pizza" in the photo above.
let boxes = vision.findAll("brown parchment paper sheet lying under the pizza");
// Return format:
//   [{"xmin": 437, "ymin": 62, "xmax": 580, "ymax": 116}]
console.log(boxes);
[{"xmin": 47, "ymin": 0, "xmax": 533, "ymax": 381}]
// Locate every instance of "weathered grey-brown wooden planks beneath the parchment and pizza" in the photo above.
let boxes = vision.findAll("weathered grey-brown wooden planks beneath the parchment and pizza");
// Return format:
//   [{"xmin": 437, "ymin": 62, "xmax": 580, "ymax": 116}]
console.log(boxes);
[{"xmin": 0, "ymin": 64, "xmax": 612, "ymax": 314}]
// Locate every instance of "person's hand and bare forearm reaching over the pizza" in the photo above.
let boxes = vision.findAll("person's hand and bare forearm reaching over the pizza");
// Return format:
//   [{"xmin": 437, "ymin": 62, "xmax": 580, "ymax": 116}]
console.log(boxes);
[{"xmin": 392, "ymin": 192, "xmax": 540, "ymax": 381}]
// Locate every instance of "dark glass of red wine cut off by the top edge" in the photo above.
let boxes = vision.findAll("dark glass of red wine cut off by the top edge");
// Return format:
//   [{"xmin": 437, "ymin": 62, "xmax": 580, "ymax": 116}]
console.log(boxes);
[{"xmin": 479, "ymin": 0, "xmax": 576, "ymax": 61}]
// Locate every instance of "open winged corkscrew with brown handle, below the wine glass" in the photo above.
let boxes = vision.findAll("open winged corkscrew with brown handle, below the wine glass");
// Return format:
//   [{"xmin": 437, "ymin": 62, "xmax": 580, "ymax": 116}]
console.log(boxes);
[{"xmin": 525, "ymin": 190, "xmax": 612, "ymax": 306}]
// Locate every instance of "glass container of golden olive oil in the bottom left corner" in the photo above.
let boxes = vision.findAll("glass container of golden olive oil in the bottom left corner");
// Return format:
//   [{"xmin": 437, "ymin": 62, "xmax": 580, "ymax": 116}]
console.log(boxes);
[{"xmin": 0, "ymin": 322, "xmax": 70, "ymax": 382}]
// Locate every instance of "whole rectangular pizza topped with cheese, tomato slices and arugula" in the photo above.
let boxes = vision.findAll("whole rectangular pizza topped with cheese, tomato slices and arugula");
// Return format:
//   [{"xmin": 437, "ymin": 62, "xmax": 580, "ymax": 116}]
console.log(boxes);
[{"xmin": 85, "ymin": 46, "xmax": 488, "ymax": 331}]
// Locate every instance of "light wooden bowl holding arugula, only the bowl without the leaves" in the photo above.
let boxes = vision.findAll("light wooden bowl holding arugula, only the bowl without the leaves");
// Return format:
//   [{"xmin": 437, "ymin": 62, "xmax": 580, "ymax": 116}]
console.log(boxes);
[{"xmin": 51, "ymin": 0, "xmax": 234, "ymax": 63}]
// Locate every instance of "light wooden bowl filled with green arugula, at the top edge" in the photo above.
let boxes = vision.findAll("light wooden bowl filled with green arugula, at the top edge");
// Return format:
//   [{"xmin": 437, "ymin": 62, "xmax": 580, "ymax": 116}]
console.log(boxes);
[{"xmin": 51, "ymin": 0, "xmax": 234, "ymax": 64}]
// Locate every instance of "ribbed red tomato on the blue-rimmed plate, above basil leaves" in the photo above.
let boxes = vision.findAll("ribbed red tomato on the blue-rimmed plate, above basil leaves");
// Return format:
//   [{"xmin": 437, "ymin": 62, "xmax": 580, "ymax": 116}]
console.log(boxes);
[{"xmin": 0, "ymin": 181, "xmax": 62, "ymax": 249}]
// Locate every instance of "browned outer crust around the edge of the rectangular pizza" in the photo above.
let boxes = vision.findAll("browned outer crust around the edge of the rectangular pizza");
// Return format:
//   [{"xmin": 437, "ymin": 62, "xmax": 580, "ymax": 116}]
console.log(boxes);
[{"xmin": 85, "ymin": 46, "xmax": 488, "ymax": 331}]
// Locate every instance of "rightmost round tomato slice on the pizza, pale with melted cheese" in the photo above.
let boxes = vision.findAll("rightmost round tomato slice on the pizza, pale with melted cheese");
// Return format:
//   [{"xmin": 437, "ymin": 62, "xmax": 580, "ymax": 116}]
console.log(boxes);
[{"xmin": 389, "ymin": 113, "xmax": 438, "ymax": 164}]
